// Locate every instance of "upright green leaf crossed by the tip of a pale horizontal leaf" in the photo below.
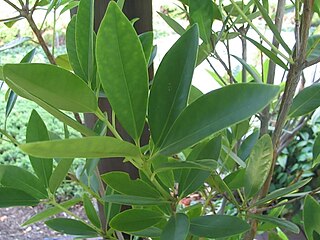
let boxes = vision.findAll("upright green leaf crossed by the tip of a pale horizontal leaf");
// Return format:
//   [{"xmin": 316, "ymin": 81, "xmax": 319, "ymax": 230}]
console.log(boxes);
[{"xmin": 26, "ymin": 110, "xmax": 53, "ymax": 187}]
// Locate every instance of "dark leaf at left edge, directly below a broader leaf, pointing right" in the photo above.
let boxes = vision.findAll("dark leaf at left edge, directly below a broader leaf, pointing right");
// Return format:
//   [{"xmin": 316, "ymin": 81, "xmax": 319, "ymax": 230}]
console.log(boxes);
[{"xmin": 0, "ymin": 187, "xmax": 39, "ymax": 208}]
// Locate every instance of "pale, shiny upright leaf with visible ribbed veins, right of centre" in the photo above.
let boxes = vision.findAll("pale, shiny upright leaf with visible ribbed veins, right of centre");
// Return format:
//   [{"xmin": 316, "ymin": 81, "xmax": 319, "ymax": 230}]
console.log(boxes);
[{"xmin": 244, "ymin": 134, "xmax": 273, "ymax": 199}]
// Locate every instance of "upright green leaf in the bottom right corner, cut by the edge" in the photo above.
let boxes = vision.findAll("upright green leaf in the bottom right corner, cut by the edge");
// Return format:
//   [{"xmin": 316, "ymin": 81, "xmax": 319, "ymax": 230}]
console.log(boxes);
[{"xmin": 303, "ymin": 195, "xmax": 320, "ymax": 240}]
